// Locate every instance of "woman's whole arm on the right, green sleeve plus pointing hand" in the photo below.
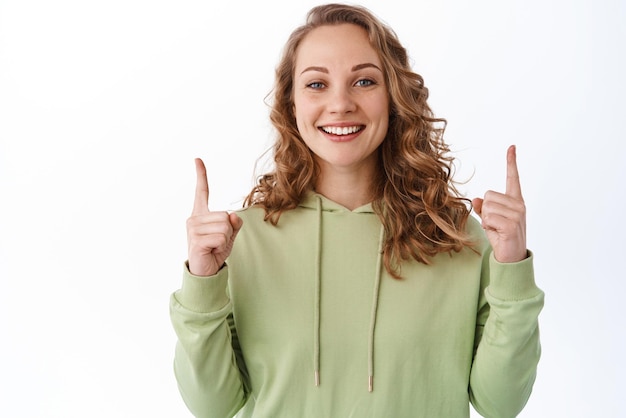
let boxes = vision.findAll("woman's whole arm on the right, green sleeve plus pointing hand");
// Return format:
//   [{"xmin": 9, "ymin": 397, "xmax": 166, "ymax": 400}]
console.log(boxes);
[{"xmin": 469, "ymin": 146, "xmax": 543, "ymax": 417}]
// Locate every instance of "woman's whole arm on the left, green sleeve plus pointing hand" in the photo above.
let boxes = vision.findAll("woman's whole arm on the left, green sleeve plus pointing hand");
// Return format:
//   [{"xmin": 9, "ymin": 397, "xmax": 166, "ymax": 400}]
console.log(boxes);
[{"xmin": 170, "ymin": 159, "xmax": 246, "ymax": 418}]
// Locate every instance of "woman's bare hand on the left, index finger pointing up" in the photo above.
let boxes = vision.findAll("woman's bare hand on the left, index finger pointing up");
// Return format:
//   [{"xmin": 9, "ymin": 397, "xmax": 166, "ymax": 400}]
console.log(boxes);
[{"xmin": 187, "ymin": 158, "xmax": 243, "ymax": 276}]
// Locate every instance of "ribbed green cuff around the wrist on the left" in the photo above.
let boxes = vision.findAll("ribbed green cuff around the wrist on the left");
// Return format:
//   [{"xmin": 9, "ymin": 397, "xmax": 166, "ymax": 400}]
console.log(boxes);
[{"xmin": 176, "ymin": 262, "xmax": 230, "ymax": 313}]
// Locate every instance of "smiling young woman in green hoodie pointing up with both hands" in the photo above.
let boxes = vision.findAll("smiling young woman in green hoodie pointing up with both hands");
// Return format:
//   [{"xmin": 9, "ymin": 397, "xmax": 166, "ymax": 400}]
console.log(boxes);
[{"xmin": 171, "ymin": 5, "xmax": 543, "ymax": 418}]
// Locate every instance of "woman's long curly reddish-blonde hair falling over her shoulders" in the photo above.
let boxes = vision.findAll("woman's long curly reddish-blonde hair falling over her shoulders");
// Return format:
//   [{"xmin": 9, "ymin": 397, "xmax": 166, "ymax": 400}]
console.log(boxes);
[{"xmin": 244, "ymin": 4, "xmax": 473, "ymax": 278}]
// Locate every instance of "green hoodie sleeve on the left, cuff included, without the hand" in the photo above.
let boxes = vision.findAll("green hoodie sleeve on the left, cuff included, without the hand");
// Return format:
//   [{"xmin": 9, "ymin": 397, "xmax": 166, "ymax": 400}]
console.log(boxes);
[{"xmin": 170, "ymin": 265, "xmax": 246, "ymax": 418}]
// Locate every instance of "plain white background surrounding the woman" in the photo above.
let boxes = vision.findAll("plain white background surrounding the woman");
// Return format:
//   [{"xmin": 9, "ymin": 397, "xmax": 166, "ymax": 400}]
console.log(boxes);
[{"xmin": 0, "ymin": 0, "xmax": 626, "ymax": 418}]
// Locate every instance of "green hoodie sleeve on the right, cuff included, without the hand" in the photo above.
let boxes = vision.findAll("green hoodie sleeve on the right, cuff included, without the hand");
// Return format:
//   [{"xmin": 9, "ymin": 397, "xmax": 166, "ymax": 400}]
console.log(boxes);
[{"xmin": 469, "ymin": 252, "xmax": 544, "ymax": 418}]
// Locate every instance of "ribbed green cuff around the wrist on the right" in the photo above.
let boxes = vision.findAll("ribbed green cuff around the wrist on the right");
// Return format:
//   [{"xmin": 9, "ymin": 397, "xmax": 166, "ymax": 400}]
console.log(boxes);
[{"xmin": 489, "ymin": 251, "xmax": 541, "ymax": 300}]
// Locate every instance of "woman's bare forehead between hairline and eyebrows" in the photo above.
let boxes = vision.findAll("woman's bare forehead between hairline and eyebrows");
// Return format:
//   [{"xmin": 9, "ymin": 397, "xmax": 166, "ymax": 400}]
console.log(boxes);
[{"xmin": 295, "ymin": 23, "xmax": 380, "ymax": 72}]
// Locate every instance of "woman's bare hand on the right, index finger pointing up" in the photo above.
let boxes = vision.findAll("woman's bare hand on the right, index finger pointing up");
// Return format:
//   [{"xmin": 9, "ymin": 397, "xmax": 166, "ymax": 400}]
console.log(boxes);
[{"xmin": 472, "ymin": 145, "xmax": 528, "ymax": 263}]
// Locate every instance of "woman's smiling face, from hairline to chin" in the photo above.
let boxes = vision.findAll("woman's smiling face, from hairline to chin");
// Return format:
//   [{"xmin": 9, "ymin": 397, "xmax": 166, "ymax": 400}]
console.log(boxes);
[{"xmin": 293, "ymin": 24, "xmax": 389, "ymax": 175}]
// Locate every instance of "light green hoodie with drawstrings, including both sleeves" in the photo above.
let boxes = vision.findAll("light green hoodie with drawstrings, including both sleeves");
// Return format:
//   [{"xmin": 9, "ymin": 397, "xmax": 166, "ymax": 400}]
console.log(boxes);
[{"xmin": 170, "ymin": 194, "xmax": 543, "ymax": 418}]
